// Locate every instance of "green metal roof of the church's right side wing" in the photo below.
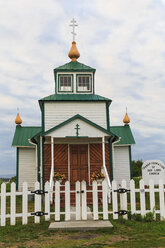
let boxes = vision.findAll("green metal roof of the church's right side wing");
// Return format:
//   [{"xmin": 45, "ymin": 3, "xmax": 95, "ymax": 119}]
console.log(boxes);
[{"xmin": 110, "ymin": 125, "xmax": 135, "ymax": 145}]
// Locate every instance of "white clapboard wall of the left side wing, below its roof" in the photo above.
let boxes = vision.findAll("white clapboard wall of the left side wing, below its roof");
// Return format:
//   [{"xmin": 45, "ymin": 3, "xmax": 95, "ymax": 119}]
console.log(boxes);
[{"xmin": 18, "ymin": 148, "xmax": 37, "ymax": 191}]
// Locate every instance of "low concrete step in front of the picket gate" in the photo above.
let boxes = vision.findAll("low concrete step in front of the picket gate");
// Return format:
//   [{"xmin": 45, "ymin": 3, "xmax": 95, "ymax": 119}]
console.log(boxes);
[{"xmin": 49, "ymin": 220, "xmax": 113, "ymax": 232}]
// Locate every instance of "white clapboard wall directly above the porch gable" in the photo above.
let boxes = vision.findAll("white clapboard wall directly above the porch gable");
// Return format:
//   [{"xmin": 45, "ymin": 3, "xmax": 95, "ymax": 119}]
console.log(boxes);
[{"xmin": 45, "ymin": 102, "xmax": 107, "ymax": 131}]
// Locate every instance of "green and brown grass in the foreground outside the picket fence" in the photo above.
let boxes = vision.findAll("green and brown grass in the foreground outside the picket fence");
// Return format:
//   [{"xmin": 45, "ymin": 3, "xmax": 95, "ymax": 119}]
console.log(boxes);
[{"xmin": 0, "ymin": 219, "xmax": 165, "ymax": 248}]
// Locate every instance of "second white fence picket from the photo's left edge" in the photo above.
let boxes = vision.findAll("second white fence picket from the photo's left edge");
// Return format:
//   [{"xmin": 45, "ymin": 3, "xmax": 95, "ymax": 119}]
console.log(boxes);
[{"xmin": 10, "ymin": 182, "xmax": 16, "ymax": 225}]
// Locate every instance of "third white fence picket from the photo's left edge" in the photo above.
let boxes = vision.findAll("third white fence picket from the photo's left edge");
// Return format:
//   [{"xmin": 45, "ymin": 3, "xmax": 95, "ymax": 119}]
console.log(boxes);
[{"xmin": 22, "ymin": 182, "xmax": 28, "ymax": 225}]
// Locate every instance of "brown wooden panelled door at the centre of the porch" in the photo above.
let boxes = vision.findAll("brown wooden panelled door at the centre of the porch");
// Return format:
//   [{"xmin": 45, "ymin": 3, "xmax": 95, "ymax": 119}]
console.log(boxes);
[{"xmin": 70, "ymin": 145, "xmax": 88, "ymax": 185}]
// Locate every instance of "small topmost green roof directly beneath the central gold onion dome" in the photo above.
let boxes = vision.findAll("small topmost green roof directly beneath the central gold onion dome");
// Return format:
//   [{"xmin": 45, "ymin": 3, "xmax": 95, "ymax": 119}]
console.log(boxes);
[{"xmin": 54, "ymin": 61, "xmax": 96, "ymax": 73}]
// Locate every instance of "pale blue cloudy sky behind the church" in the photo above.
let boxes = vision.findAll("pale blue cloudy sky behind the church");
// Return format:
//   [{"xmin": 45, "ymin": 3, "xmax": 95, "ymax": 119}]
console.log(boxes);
[{"xmin": 0, "ymin": 0, "xmax": 165, "ymax": 175}]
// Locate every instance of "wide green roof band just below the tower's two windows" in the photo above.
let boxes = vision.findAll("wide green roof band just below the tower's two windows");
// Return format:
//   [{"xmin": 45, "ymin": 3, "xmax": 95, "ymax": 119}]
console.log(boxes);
[{"xmin": 39, "ymin": 94, "xmax": 112, "ymax": 102}]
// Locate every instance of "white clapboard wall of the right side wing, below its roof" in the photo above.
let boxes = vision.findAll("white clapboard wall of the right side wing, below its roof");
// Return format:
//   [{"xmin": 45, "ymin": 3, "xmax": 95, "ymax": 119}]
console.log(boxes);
[{"xmin": 113, "ymin": 146, "xmax": 130, "ymax": 187}]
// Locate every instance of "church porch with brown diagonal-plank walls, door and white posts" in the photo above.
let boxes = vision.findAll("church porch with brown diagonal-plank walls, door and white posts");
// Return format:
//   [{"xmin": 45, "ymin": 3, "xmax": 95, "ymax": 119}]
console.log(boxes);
[{"xmin": 44, "ymin": 136, "xmax": 112, "ymax": 186}]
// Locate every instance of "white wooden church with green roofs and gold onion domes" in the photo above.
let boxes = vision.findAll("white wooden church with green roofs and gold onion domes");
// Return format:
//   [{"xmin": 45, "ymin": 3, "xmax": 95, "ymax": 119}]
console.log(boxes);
[{"xmin": 12, "ymin": 21, "xmax": 135, "ymax": 190}]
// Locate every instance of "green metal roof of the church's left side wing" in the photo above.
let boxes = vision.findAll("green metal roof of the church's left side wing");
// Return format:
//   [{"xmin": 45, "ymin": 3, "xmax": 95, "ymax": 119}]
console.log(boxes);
[{"xmin": 12, "ymin": 126, "xmax": 41, "ymax": 147}]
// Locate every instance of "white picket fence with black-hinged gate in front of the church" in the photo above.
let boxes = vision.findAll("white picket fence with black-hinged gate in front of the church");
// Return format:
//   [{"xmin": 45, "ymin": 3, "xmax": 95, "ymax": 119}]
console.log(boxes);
[{"xmin": 0, "ymin": 180, "xmax": 165, "ymax": 226}]
